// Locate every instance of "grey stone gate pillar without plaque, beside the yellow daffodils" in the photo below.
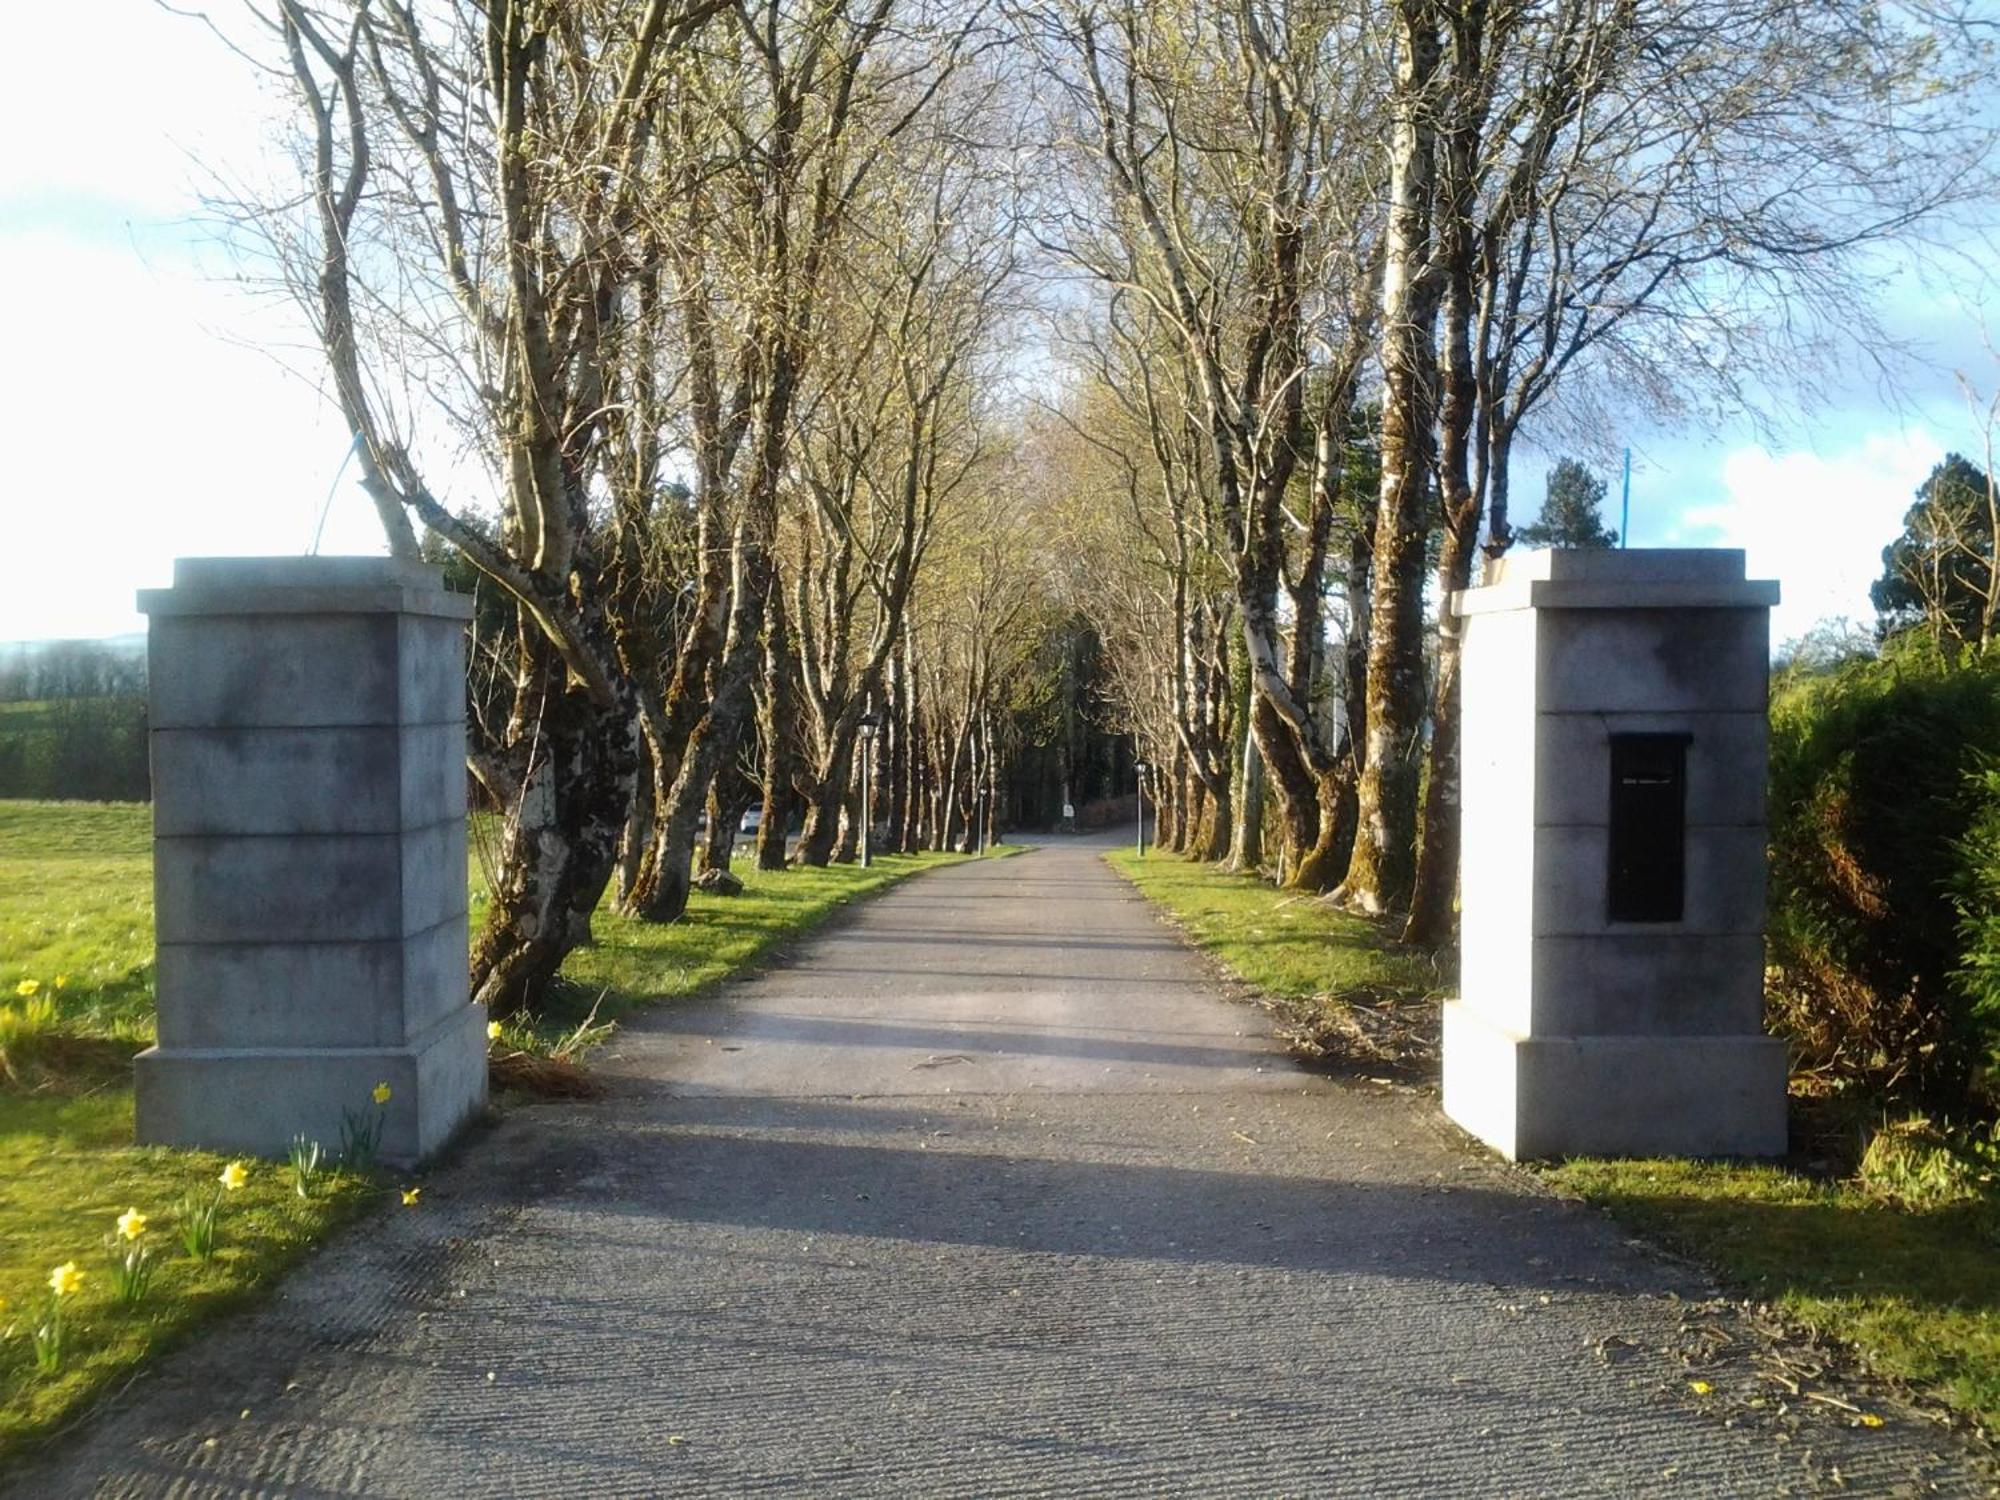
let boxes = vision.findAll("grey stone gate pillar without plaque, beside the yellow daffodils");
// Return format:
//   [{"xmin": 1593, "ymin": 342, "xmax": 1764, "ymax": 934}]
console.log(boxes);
[{"xmin": 136, "ymin": 558, "xmax": 486, "ymax": 1164}]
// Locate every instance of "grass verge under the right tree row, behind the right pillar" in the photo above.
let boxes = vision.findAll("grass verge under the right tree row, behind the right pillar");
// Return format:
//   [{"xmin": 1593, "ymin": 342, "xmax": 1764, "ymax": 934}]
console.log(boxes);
[{"xmin": 1104, "ymin": 850, "xmax": 1438, "ymax": 1076}]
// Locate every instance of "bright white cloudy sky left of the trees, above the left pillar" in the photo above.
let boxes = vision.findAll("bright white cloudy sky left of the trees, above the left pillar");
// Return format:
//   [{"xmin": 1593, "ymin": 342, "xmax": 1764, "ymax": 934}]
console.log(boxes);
[{"xmin": 0, "ymin": 0, "xmax": 382, "ymax": 640}]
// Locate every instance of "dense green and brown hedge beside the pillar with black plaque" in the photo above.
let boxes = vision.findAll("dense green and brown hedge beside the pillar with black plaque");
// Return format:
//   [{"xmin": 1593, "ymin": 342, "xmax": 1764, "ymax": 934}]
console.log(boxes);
[{"xmin": 1766, "ymin": 642, "xmax": 2000, "ymax": 1112}]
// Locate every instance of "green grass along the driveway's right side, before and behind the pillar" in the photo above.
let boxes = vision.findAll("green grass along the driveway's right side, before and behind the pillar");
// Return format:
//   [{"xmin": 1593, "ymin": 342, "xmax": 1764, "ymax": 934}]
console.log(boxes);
[{"xmin": 1106, "ymin": 850, "xmax": 2000, "ymax": 1440}]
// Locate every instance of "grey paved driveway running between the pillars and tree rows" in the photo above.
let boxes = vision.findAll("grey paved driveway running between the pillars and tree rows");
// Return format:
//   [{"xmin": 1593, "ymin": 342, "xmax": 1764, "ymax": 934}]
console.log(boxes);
[{"xmin": 14, "ymin": 840, "xmax": 1986, "ymax": 1498}]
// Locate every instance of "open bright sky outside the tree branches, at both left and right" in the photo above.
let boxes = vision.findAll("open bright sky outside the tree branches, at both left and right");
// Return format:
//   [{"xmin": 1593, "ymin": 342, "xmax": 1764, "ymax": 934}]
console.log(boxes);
[{"xmin": 0, "ymin": 0, "xmax": 2000, "ymax": 640}]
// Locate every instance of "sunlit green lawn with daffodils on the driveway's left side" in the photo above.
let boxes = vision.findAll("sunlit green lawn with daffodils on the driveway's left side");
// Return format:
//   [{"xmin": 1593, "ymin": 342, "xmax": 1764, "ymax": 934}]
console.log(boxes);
[{"xmin": 0, "ymin": 802, "xmax": 968, "ymax": 1466}]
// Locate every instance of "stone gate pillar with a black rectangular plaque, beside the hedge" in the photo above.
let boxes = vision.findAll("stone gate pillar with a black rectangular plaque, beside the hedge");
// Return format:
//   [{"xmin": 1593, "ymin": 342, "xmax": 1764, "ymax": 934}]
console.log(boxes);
[{"xmin": 1444, "ymin": 550, "xmax": 1786, "ymax": 1158}]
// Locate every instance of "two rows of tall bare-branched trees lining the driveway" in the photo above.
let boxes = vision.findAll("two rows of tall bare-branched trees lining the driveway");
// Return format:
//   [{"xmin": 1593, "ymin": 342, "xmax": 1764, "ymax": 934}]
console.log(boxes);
[{"xmin": 211, "ymin": 0, "xmax": 1994, "ymax": 1008}]
